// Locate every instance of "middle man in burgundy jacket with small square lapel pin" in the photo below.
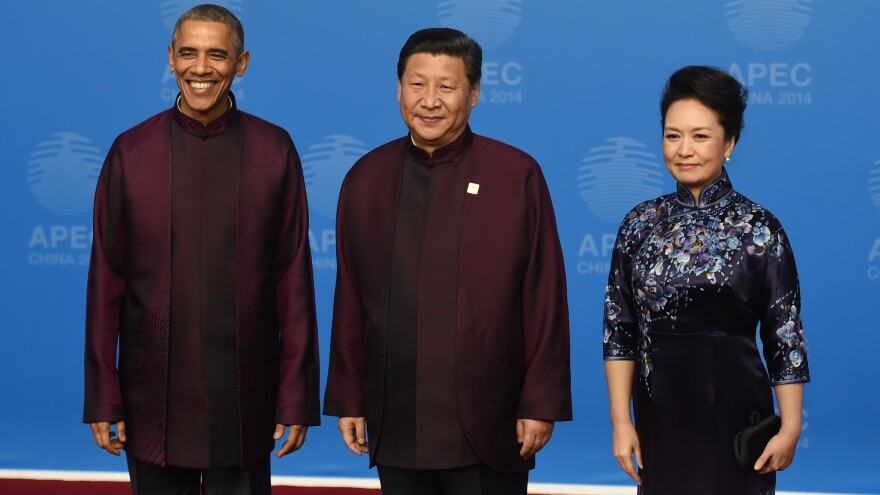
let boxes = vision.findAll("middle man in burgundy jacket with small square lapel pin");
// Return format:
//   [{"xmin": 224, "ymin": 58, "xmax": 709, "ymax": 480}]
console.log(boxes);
[{"xmin": 324, "ymin": 29, "xmax": 571, "ymax": 495}]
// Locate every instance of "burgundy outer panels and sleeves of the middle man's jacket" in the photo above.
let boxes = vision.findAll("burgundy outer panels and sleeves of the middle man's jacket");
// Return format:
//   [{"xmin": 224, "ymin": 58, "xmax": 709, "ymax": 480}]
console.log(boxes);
[{"xmin": 324, "ymin": 134, "xmax": 572, "ymax": 472}]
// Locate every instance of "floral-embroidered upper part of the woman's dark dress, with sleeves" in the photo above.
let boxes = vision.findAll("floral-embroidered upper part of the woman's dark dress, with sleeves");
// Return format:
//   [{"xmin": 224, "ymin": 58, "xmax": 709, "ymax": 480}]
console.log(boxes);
[{"xmin": 603, "ymin": 171, "xmax": 809, "ymax": 390}]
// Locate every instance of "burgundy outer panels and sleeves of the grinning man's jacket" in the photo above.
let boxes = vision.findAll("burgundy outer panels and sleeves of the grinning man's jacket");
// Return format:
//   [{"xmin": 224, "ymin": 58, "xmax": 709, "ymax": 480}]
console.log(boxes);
[{"xmin": 83, "ymin": 106, "xmax": 320, "ymax": 465}]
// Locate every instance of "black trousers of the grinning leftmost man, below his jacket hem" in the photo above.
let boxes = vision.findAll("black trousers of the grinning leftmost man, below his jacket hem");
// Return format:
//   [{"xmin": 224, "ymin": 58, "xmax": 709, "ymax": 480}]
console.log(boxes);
[{"xmin": 125, "ymin": 455, "xmax": 272, "ymax": 495}]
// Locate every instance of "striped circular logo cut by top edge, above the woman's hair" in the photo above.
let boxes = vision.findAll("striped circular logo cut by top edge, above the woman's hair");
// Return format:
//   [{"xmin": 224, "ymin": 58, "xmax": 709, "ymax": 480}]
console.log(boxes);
[{"xmin": 724, "ymin": 0, "xmax": 813, "ymax": 51}]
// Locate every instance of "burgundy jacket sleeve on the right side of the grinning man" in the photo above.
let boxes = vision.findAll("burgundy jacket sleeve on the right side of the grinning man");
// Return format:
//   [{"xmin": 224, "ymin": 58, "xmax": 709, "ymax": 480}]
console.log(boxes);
[{"xmin": 275, "ymin": 143, "xmax": 321, "ymax": 425}]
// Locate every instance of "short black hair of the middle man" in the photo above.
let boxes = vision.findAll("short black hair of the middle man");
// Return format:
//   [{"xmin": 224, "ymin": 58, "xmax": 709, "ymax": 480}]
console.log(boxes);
[{"xmin": 397, "ymin": 28, "xmax": 483, "ymax": 86}]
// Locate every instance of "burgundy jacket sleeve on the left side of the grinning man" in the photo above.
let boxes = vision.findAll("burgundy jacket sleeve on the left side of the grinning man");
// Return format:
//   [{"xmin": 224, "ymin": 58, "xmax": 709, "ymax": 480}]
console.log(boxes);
[{"xmin": 83, "ymin": 143, "xmax": 125, "ymax": 423}]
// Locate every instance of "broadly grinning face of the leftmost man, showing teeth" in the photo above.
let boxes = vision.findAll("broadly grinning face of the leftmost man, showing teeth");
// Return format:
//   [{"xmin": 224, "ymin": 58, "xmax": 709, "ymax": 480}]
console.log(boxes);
[{"xmin": 168, "ymin": 21, "xmax": 250, "ymax": 125}]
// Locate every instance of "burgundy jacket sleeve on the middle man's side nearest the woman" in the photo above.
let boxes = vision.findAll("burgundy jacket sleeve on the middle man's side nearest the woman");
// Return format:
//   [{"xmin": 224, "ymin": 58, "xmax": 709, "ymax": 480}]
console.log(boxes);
[{"xmin": 517, "ymin": 166, "xmax": 572, "ymax": 421}]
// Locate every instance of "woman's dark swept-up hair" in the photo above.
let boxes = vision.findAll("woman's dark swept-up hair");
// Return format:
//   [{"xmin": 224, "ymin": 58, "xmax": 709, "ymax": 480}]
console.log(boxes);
[{"xmin": 660, "ymin": 65, "xmax": 749, "ymax": 143}]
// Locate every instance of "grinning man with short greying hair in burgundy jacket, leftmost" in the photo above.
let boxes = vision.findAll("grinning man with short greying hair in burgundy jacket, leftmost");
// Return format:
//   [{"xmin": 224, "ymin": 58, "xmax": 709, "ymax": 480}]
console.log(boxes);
[{"xmin": 83, "ymin": 5, "xmax": 320, "ymax": 495}]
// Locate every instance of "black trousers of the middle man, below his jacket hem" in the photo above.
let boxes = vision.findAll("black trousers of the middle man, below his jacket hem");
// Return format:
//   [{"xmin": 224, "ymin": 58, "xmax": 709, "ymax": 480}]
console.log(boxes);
[{"xmin": 376, "ymin": 464, "xmax": 529, "ymax": 495}]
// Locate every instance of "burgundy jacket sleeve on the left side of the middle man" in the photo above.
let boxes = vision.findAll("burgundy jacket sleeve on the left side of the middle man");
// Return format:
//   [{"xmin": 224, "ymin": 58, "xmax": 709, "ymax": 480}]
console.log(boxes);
[{"xmin": 324, "ymin": 176, "xmax": 366, "ymax": 417}]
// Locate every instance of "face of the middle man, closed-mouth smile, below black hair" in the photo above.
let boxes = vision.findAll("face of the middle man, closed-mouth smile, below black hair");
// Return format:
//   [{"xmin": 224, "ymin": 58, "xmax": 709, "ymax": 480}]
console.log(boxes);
[{"xmin": 397, "ymin": 53, "xmax": 480, "ymax": 153}]
